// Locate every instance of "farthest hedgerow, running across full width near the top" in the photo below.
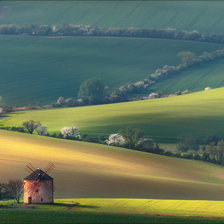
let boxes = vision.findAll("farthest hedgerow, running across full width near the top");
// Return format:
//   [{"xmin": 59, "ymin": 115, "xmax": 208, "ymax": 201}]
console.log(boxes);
[{"xmin": 3, "ymin": 23, "xmax": 224, "ymax": 43}]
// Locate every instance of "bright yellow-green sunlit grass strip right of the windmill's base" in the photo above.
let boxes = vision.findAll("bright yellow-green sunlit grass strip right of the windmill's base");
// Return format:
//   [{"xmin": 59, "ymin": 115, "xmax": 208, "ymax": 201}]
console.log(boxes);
[{"xmin": 37, "ymin": 198, "xmax": 224, "ymax": 217}]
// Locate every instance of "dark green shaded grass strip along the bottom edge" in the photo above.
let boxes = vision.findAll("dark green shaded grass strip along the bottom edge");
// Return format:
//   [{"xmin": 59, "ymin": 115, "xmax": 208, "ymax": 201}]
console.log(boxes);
[{"xmin": 0, "ymin": 209, "xmax": 223, "ymax": 224}]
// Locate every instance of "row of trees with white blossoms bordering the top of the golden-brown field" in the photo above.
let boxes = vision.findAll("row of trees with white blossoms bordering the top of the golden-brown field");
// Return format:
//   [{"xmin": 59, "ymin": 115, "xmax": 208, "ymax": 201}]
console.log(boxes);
[{"xmin": 0, "ymin": 120, "xmax": 224, "ymax": 165}]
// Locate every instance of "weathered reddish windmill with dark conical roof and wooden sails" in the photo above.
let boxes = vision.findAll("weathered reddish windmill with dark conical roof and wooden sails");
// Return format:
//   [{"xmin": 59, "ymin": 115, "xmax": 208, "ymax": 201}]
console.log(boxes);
[{"xmin": 24, "ymin": 162, "xmax": 55, "ymax": 204}]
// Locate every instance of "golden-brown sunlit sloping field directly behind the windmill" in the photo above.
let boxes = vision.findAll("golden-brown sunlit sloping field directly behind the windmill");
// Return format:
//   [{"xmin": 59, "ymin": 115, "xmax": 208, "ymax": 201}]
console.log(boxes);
[{"xmin": 0, "ymin": 131, "xmax": 224, "ymax": 200}]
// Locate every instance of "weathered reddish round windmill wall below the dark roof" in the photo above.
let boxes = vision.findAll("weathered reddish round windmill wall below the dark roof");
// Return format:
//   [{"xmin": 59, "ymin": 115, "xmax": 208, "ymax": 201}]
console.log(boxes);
[{"xmin": 24, "ymin": 180, "xmax": 54, "ymax": 204}]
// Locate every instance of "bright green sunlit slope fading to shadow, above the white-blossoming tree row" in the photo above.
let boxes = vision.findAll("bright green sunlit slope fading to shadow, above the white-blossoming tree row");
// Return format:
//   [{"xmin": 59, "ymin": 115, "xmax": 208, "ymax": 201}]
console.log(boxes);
[{"xmin": 1, "ymin": 88, "xmax": 224, "ymax": 142}]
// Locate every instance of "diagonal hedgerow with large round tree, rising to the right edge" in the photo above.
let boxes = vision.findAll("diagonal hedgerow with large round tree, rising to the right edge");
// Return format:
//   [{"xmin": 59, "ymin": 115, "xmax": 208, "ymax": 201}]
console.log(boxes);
[{"xmin": 53, "ymin": 48, "xmax": 224, "ymax": 107}]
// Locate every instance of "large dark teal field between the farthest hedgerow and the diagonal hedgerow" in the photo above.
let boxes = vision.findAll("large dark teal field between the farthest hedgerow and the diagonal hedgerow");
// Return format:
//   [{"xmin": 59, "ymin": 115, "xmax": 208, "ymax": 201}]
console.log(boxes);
[{"xmin": 0, "ymin": 36, "xmax": 220, "ymax": 105}]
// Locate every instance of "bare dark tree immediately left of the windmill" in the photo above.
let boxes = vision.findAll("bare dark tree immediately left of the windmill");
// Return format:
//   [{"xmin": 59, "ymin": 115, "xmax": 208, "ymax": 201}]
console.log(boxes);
[{"xmin": 5, "ymin": 180, "xmax": 23, "ymax": 203}]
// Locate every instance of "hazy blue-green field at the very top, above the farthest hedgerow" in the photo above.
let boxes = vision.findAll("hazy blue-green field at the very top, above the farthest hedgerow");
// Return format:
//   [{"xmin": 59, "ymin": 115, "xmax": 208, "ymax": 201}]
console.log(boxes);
[{"xmin": 0, "ymin": 1, "xmax": 224, "ymax": 33}]
